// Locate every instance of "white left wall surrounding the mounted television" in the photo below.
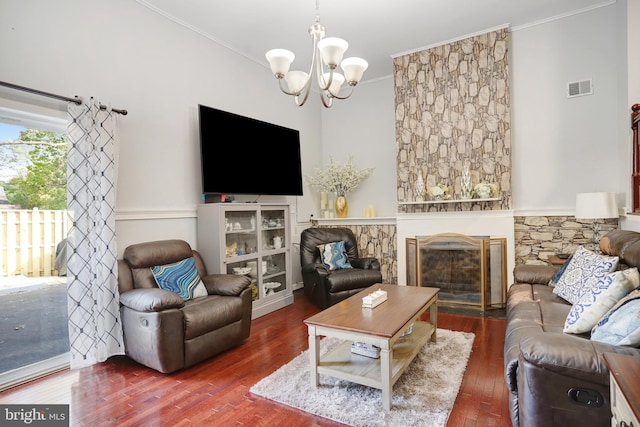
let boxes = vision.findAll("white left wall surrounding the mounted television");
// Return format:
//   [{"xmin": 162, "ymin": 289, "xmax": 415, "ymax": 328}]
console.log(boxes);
[{"xmin": 0, "ymin": 0, "xmax": 320, "ymax": 253}]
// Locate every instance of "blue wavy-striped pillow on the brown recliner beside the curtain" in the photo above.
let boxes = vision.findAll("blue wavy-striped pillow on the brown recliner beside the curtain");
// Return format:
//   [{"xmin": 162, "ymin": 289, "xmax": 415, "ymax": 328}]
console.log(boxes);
[{"xmin": 151, "ymin": 257, "xmax": 207, "ymax": 301}]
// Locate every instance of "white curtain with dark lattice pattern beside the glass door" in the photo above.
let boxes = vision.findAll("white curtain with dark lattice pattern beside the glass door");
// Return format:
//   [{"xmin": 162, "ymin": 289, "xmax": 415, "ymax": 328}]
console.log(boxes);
[{"xmin": 67, "ymin": 98, "xmax": 124, "ymax": 369}]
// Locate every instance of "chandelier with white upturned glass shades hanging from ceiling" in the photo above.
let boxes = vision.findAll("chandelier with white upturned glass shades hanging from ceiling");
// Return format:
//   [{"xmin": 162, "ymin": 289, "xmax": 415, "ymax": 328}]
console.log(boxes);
[{"xmin": 266, "ymin": 0, "xmax": 369, "ymax": 108}]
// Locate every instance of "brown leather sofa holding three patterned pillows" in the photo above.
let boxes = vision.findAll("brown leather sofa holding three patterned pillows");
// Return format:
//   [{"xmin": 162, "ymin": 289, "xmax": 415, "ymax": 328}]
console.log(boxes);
[{"xmin": 504, "ymin": 230, "xmax": 640, "ymax": 427}]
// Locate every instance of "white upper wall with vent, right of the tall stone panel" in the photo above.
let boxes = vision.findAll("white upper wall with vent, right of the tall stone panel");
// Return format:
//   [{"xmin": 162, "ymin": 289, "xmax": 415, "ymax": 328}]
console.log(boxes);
[{"xmin": 511, "ymin": 5, "xmax": 629, "ymax": 210}]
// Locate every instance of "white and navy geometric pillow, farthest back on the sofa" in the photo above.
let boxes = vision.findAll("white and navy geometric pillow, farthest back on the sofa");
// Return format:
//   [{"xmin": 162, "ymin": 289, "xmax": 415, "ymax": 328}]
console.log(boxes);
[{"xmin": 553, "ymin": 246, "xmax": 619, "ymax": 304}]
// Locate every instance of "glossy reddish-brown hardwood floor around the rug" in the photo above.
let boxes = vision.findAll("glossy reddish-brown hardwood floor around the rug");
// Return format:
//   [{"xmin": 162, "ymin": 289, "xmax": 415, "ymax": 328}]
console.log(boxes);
[{"xmin": 0, "ymin": 290, "xmax": 511, "ymax": 427}]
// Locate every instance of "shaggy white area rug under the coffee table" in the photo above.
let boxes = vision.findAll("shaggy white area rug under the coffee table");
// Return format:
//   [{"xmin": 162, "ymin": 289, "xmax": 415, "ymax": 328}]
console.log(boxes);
[{"xmin": 250, "ymin": 329, "xmax": 475, "ymax": 427}]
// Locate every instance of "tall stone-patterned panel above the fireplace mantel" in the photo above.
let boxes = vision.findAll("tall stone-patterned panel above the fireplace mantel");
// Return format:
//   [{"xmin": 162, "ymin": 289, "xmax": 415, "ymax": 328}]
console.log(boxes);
[{"xmin": 393, "ymin": 28, "xmax": 511, "ymax": 212}]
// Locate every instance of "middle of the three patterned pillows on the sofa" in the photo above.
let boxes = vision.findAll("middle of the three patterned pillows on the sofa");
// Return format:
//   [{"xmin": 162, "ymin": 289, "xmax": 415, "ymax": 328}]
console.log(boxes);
[{"xmin": 564, "ymin": 267, "xmax": 640, "ymax": 334}]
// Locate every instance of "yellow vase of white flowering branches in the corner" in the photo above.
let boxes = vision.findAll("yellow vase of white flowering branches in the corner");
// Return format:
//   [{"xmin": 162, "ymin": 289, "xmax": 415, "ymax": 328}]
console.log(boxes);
[{"xmin": 305, "ymin": 156, "xmax": 373, "ymax": 218}]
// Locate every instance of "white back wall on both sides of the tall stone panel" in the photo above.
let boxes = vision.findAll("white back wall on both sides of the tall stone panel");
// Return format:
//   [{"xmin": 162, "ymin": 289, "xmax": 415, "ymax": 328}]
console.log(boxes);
[{"xmin": 322, "ymin": 2, "xmax": 624, "ymax": 216}]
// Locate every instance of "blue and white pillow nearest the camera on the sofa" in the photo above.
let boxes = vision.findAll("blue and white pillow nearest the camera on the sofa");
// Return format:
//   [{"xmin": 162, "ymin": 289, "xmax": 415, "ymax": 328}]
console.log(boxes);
[{"xmin": 591, "ymin": 289, "xmax": 640, "ymax": 347}]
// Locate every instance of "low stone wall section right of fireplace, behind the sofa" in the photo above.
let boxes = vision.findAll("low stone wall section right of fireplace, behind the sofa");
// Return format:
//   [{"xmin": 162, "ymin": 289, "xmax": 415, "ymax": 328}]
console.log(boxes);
[{"xmin": 514, "ymin": 216, "xmax": 618, "ymax": 265}]
